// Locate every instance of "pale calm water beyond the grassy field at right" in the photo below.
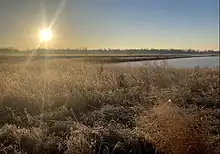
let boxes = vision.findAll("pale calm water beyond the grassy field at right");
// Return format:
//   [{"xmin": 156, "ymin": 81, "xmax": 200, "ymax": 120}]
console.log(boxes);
[{"xmin": 112, "ymin": 56, "xmax": 219, "ymax": 68}]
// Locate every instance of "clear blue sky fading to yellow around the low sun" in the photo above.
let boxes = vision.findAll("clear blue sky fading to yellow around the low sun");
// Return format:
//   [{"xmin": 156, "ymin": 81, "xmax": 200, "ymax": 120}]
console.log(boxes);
[{"xmin": 0, "ymin": 0, "xmax": 219, "ymax": 50}]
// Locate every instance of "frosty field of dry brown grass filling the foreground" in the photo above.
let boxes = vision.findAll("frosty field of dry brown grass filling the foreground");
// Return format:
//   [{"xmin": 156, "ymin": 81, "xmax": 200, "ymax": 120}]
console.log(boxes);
[{"xmin": 0, "ymin": 58, "xmax": 220, "ymax": 154}]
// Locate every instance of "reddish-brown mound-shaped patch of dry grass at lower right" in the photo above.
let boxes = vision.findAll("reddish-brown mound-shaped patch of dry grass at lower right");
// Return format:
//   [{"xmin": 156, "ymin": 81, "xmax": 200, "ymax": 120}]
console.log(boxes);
[{"xmin": 138, "ymin": 103, "xmax": 216, "ymax": 154}]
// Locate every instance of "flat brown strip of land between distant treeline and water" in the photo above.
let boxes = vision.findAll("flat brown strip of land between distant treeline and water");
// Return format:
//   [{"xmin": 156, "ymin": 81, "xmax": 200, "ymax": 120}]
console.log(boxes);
[{"xmin": 0, "ymin": 54, "xmax": 219, "ymax": 63}]
